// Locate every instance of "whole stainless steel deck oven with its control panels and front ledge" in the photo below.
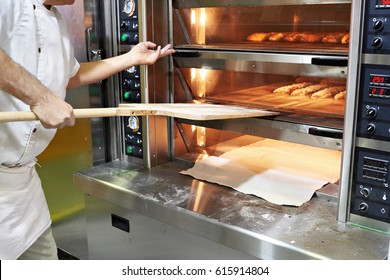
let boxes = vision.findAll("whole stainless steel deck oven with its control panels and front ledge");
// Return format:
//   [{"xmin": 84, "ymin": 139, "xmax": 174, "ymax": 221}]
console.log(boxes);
[{"xmin": 74, "ymin": 0, "xmax": 390, "ymax": 259}]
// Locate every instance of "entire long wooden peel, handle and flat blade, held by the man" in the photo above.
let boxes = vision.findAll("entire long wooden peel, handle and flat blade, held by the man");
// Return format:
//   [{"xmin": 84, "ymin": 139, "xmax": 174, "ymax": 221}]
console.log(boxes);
[{"xmin": 0, "ymin": 103, "xmax": 279, "ymax": 122}]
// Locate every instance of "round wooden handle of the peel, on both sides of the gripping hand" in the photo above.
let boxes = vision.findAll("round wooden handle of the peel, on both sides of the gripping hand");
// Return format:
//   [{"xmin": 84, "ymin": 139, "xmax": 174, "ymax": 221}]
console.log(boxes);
[{"xmin": 0, "ymin": 108, "xmax": 118, "ymax": 122}]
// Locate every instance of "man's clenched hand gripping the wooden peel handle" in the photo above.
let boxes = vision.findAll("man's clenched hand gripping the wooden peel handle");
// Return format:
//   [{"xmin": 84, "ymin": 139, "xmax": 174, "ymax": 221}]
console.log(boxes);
[{"xmin": 30, "ymin": 93, "xmax": 75, "ymax": 128}]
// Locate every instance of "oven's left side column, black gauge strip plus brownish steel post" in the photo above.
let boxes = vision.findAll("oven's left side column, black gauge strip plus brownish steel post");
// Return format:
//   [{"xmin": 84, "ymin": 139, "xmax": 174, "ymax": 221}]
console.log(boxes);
[{"xmin": 113, "ymin": 0, "xmax": 170, "ymax": 168}]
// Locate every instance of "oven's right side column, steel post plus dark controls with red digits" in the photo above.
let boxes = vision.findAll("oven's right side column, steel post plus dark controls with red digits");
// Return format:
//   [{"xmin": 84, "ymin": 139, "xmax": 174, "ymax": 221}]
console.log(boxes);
[{"xmin": 339, "ymin": 0, "xmax": 390, "ymax": 233}]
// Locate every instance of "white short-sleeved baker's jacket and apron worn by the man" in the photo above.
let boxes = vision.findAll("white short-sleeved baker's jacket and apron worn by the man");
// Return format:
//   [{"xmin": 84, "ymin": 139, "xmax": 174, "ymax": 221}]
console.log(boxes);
[{"xmin": 0, "ymin": 0, "xmax": 80, "ymax": 259}]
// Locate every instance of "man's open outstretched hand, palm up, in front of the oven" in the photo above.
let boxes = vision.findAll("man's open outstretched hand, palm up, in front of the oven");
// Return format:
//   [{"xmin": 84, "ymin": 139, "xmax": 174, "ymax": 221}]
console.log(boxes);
[{"xmin": 127, "ymin": 42, "xmax": 175, "ymax": 65}]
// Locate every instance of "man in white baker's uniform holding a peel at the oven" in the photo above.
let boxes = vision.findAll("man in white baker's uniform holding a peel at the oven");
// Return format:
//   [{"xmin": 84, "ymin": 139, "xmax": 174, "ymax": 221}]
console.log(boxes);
[{"xmin": 0, "ymin": 0, "xmax": 174, "ymax": 260}]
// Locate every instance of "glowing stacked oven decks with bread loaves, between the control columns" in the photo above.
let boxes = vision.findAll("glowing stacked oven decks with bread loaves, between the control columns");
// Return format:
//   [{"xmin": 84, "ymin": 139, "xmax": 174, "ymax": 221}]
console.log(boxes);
[{"xmin": 168, "ymin": 1, "xmax": 351, "ymax": 192}]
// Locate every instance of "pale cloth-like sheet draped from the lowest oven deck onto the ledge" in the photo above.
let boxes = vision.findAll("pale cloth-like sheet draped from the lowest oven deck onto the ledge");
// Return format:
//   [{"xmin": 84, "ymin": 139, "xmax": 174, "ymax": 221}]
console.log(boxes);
[{"xmin": 180, "ymin": 139, "xmax": 341, "ymax": 206}]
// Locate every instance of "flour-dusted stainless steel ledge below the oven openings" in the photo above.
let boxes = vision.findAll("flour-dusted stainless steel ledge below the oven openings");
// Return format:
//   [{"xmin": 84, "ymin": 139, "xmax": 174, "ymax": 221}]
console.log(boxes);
[{"xmin": 74, "ymin": 161, "xmax": 389, "ymax": 260}]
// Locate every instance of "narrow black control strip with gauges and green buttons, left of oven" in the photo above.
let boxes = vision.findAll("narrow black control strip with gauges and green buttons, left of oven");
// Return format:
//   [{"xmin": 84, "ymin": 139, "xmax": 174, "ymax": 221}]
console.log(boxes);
[{"xmin": 118, "ymin": 0, "xmax": 143, "ymax": 159}]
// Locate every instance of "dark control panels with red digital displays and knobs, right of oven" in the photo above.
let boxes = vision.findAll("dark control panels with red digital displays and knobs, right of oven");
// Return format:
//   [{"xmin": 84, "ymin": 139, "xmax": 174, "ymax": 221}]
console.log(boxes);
[{"xmin": 350, "ymin": 0, "xmax": 390, "ymax": 228}]
